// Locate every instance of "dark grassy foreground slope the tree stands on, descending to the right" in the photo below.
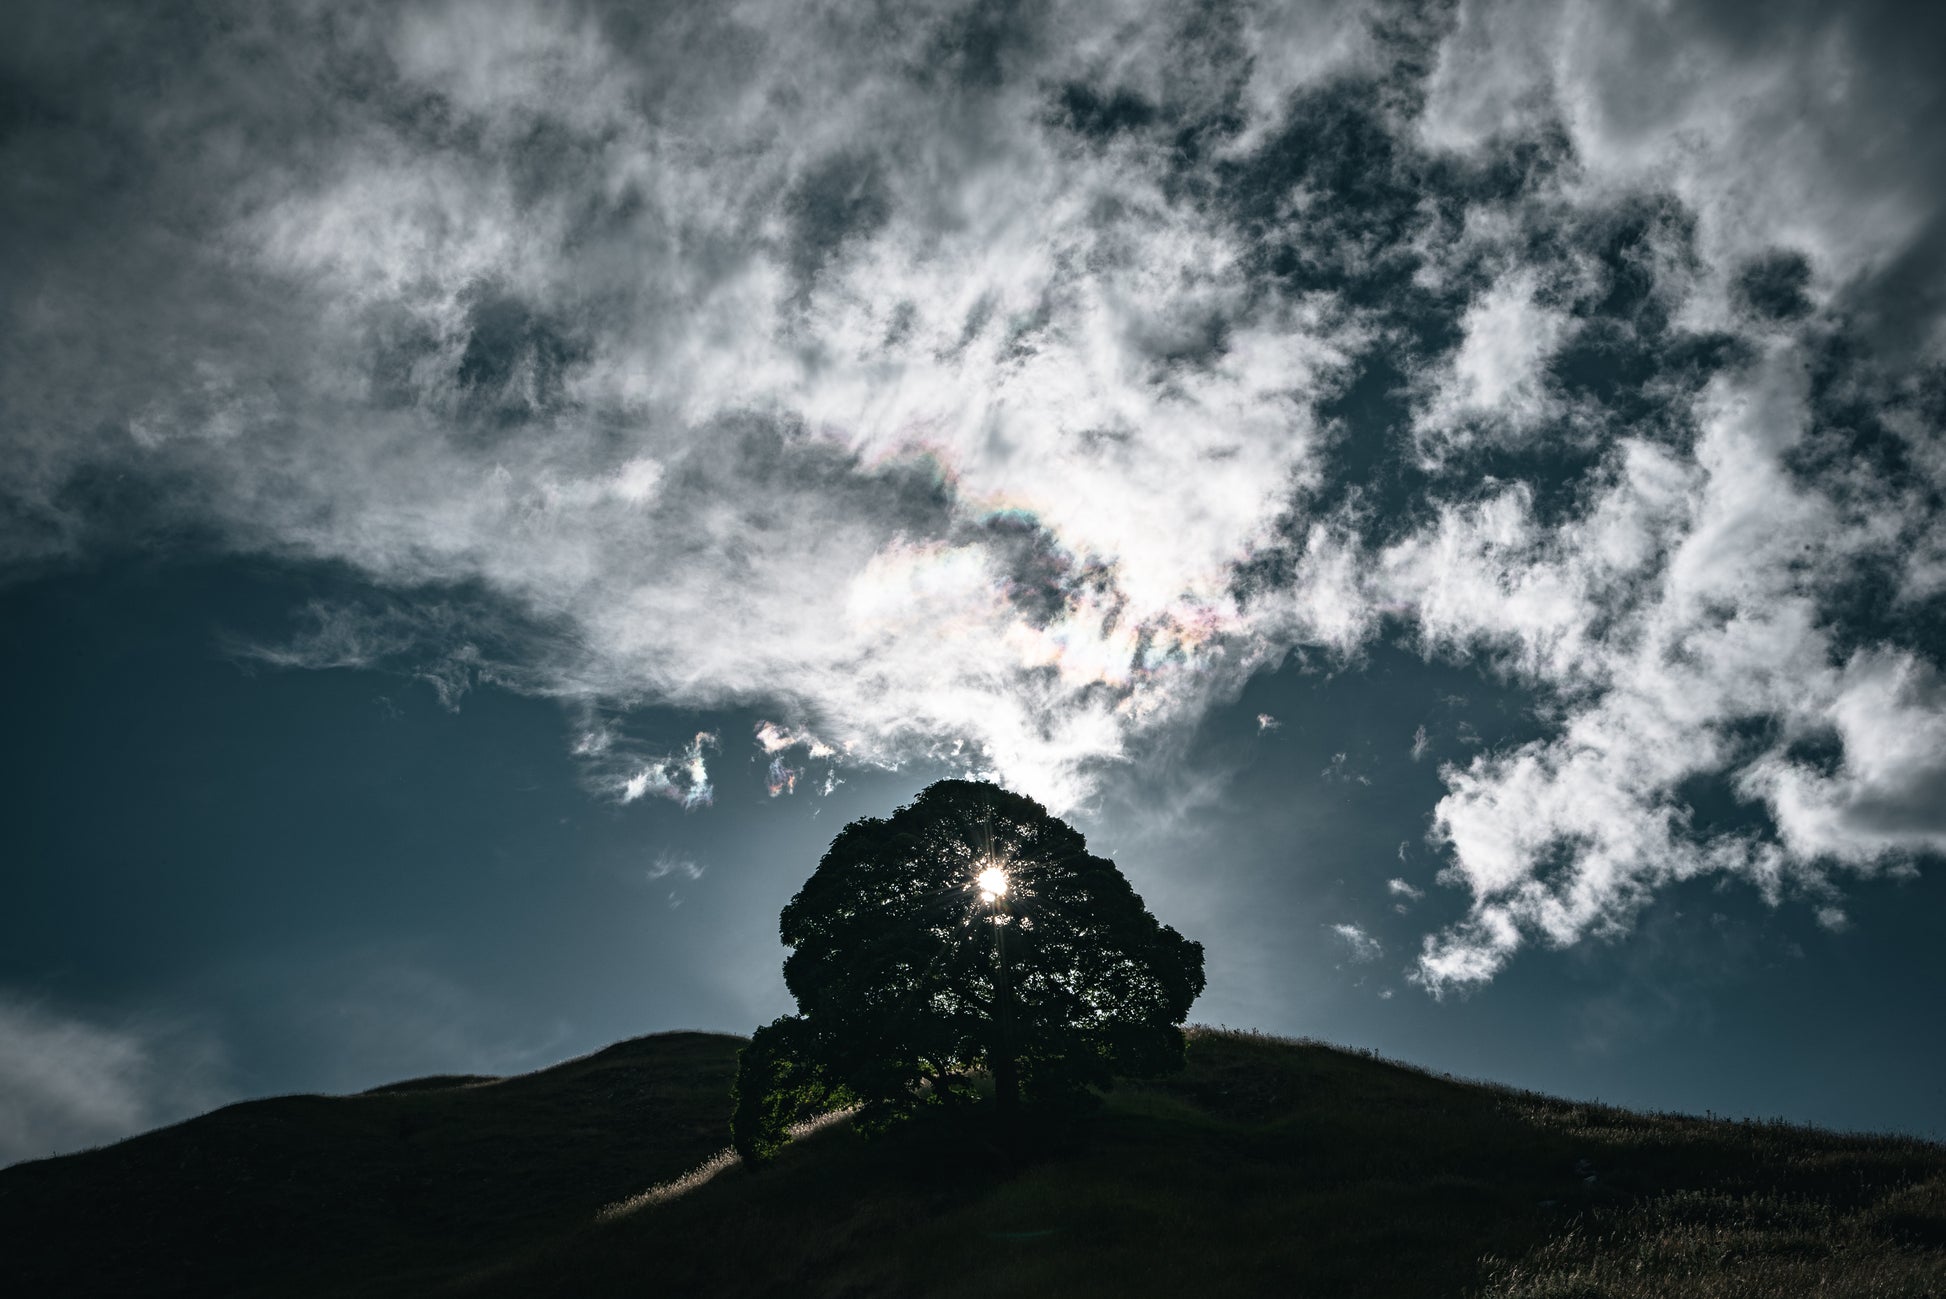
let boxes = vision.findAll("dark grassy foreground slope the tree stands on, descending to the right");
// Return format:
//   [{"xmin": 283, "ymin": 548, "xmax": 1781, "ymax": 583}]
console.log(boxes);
[{"xmin": 461, "ymin": 1031, "xmax": 1946, "ymax": 1297}]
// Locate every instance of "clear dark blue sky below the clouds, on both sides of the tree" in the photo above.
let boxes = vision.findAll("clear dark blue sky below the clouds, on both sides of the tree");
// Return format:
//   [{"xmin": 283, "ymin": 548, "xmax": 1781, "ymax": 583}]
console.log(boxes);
[{"xmin": 0, "ymin": 558, "xmax": 1946, "ymax": 1155}]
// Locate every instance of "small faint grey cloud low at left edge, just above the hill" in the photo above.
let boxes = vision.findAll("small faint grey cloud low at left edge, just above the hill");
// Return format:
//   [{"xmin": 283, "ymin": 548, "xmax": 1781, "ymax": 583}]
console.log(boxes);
[{"xmin": 0, "ymin": 996, "xmax": 222, "ymax": 1165}]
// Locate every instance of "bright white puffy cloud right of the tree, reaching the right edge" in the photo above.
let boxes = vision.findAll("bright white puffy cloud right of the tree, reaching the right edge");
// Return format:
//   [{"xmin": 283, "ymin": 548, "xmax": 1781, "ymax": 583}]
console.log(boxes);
[{"xmin": 1415, "ymin": 352, "xmax": 1946, "ymax": 990}]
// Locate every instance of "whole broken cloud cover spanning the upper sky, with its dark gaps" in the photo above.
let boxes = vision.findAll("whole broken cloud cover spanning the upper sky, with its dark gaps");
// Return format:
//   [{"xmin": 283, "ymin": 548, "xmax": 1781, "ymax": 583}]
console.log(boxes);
[{"xmin": 0, "ymin": 0, "xmax": 1946, "ymax": 990}]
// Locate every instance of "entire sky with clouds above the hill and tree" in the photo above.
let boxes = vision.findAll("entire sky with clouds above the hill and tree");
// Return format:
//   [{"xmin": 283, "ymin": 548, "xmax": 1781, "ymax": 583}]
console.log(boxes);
[{"xmin": 0, "ymin": 0, "xmax": 1946, "ymax": 1161}]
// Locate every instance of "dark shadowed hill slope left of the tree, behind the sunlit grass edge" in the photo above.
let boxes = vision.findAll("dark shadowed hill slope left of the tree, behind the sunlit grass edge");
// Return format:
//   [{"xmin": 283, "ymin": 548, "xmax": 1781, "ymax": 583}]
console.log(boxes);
[{"xmin": 0, "ymin": 1033, "xmax": 743, "ymax": 1297}]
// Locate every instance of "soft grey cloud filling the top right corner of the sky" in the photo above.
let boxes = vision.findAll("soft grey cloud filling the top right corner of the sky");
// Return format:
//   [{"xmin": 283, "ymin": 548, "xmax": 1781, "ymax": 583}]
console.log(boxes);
[{"xmin": 1421, "ymin": 2, "xmax": 1946, "ymax": 340}]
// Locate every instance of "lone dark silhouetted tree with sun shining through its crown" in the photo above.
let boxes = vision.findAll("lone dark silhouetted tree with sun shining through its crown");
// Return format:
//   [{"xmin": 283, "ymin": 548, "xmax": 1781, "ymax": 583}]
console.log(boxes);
[{"xmin": 730, "ymin": 780, "xmax": 1203, "ymax": 1163}]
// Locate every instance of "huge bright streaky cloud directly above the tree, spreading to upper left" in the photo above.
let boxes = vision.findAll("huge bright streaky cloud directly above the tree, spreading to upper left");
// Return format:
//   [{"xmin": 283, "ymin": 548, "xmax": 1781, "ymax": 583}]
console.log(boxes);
[{"xmin": 10, "ymin": 6, "xmax": 1356, "ymax": 805}]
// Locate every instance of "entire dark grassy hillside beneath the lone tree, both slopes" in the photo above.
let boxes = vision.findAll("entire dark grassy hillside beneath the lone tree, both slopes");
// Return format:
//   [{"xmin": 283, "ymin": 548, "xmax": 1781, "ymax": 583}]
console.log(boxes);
[{"xmin": 0, "ymin": 1031, "xmax": 1946, "ymax": 1299}]
